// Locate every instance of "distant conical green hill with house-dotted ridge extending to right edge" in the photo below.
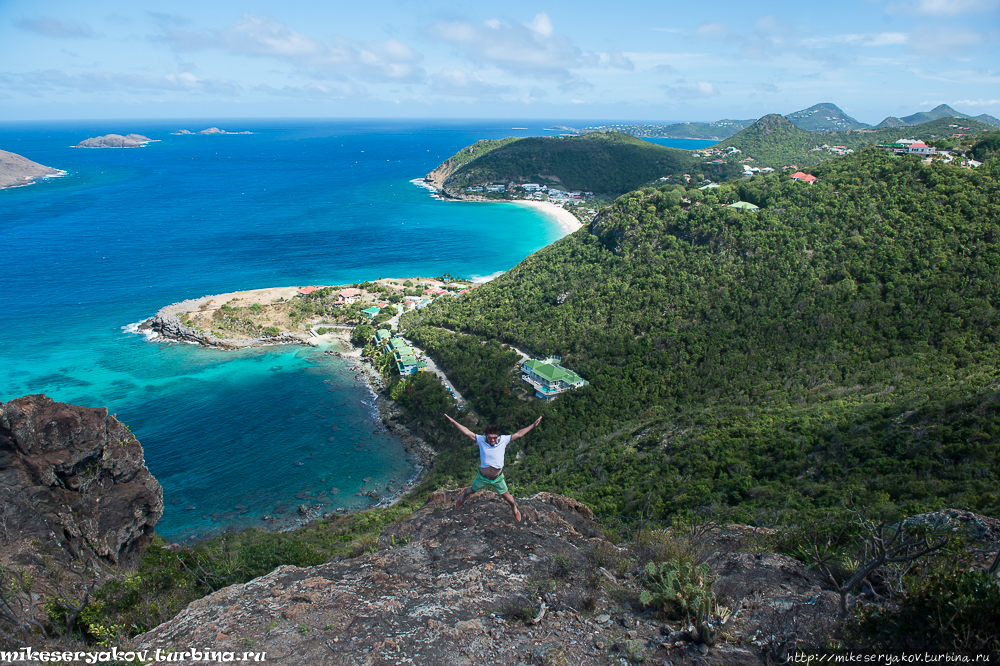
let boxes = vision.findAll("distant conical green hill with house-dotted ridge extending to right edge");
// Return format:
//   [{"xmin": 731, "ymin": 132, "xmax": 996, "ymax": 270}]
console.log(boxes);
[{"xmin": 714, "ymin": 114, "xmax": 996, "ymax": 168}]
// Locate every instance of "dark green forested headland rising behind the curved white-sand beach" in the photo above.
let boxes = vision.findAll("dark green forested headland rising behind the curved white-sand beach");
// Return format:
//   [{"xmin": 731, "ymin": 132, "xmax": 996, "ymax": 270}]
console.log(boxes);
[{"xmin": 432, "ymin": 132, "xmax": 729, "ymax": 196}]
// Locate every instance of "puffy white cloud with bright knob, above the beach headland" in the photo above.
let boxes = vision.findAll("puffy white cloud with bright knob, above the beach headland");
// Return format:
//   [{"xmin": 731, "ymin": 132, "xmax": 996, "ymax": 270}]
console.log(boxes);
[{"xmin": 430, "ymin": 13, "xmax": 600, "ymax": 80}]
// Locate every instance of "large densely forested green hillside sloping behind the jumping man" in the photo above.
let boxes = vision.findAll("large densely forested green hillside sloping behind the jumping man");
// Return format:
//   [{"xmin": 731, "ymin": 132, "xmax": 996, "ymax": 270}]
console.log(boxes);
[{"xmin": 393, "ymin": 149, "xmax": 1000, "ymax": 524}]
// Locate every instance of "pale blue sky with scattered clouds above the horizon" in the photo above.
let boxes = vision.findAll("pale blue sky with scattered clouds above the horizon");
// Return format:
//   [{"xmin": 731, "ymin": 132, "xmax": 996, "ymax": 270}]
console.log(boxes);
[{"xmin": 0, "ymin": 0, "xmax": 1000, "ymax": 123}]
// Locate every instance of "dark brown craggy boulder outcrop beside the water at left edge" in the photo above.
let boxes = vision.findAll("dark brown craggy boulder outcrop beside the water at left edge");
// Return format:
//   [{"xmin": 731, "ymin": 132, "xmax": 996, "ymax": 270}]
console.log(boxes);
[{"xmin": 0, "ymin": 395, "xmax": 163, "ymax": 563}]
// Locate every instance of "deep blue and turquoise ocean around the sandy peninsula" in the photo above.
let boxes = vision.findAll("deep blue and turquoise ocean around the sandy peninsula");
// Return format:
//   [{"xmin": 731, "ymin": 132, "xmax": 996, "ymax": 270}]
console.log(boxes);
[{"xmin": 0, "ymin": 119, "xmax": 711, "ymax": 540}]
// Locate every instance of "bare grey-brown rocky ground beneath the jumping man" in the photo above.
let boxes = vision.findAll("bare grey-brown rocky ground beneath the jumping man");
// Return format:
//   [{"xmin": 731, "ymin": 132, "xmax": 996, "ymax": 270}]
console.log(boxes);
[{"xmin": 135, "ymin": 491, "xmax": 838, "ymax": 666}]
